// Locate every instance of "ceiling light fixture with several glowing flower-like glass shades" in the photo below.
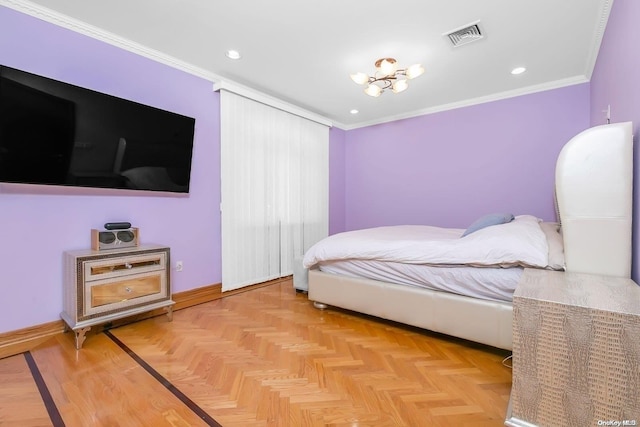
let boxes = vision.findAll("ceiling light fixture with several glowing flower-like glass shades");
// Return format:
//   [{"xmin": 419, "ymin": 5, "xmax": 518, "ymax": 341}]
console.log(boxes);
[{"xmin": 351, "ymin": 58, "xmax": 424, "ymax": 97}]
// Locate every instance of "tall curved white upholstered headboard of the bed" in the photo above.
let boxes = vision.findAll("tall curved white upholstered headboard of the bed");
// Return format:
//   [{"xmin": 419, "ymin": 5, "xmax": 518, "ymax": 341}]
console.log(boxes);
[{"xmin": 556, "ymin": 122, "xmax": 633, "ymax": 278}]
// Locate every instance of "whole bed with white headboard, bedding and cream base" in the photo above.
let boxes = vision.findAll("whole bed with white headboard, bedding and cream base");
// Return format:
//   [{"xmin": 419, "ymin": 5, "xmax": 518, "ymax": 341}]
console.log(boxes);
[{"xmin": 302, "ymin": 122, "xmax": 633, "ymax": 350}]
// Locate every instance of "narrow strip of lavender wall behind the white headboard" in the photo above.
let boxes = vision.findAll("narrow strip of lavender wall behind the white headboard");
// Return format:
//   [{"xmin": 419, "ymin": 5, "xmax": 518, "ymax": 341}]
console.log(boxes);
[{"xmin": 591, "ymin": 0, "xmax": 640, "ymax": 283}]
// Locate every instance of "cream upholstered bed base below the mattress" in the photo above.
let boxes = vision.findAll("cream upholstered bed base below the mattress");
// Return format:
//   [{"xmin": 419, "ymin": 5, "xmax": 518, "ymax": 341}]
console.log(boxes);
[{"xmin": 308, "ymin": 269, "xmax": 513, "ymax": 350}]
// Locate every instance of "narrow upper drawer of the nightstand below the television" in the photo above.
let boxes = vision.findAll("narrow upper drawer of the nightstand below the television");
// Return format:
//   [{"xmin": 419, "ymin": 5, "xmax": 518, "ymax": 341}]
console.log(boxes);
[{"xmin": 84, "ymin": 253, "xmax": 167, "ymax": 281}]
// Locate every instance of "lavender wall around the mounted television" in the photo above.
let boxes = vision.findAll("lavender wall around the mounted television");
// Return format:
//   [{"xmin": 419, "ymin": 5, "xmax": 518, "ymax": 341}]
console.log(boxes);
[{"xmin": 0, "ymin": 7, "xmax": 221, "ymax": 333}]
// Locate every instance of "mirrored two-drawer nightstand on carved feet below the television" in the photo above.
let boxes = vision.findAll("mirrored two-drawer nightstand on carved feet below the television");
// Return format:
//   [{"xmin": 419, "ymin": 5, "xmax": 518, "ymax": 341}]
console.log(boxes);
[{"xmin": 60, "ymin": 244, "xmax": 174, "ymax": 349}]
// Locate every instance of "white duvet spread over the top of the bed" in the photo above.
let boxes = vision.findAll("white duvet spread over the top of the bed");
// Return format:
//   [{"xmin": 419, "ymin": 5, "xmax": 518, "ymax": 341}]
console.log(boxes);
[{"xmin": 303, "ymin": 215, "xmax": 549, "ymax": 268}]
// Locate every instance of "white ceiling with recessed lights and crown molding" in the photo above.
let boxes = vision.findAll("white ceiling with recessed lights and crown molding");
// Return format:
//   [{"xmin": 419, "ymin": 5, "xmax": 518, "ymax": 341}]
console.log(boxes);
[{"xmin": 7, "ymin": 0, "xmax": 613, "ymax": 129}]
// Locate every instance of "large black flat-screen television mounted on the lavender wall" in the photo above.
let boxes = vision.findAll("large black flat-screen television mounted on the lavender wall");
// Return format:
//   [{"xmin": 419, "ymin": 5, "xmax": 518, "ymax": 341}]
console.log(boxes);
[{"xmin": 0, "ymin": 65, "xmax": 195, "ymax": 193}]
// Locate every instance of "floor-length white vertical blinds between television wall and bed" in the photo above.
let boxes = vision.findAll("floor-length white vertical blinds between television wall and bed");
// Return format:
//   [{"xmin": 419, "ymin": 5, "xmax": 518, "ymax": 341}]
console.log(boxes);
[{"xmin": 220, "ymin": 90, "xmax": 329, "ymax": 291}]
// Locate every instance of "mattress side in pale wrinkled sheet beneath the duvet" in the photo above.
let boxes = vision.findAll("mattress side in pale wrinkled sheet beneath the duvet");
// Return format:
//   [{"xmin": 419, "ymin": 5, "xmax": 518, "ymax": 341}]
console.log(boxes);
[{"xmin": 319, "ymin": 260, "xmax": 524, "ymax": 302}]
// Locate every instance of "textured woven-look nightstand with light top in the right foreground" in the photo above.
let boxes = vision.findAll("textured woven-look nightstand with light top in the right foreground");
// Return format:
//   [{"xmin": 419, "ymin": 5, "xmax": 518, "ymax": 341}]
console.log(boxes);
[{"xmin": 505, "ymin": 269, "xmax": 640, "ymax": 427}]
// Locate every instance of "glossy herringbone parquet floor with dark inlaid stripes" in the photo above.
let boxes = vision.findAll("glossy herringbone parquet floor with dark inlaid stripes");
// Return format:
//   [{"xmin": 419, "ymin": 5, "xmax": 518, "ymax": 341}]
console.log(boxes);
[{"xmin": 0, "ymin": 281, "xmax": 511, "ymax": 427}]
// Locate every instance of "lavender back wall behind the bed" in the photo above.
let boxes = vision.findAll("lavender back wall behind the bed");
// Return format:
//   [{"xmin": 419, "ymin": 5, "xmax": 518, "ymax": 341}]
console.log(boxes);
[{"xmin": 345, "ymin": 84, "xmax": 589, "ymax": 230}]
